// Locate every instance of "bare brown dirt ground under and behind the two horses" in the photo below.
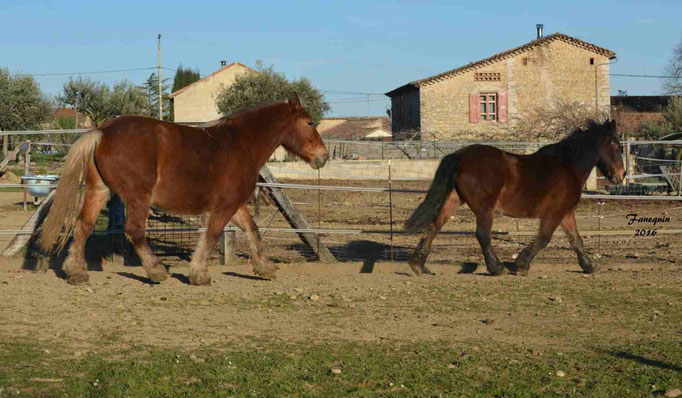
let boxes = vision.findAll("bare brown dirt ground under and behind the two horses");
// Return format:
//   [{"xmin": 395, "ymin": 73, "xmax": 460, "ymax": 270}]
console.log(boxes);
[{"xmin": 0, "ymin": 181, "xmax": 682, "ymax": 350}]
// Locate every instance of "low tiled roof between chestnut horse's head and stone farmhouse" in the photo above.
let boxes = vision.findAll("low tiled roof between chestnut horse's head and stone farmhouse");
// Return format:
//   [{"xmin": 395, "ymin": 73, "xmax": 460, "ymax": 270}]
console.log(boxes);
[{"xmin": 317, "ymin": 116, "xmax": 391, "ymax": 140}]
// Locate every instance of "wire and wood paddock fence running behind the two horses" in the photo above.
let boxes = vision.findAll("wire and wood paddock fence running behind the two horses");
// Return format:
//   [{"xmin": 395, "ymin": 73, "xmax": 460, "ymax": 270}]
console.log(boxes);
[{"xmin": 0, "ymin": 130, "xmax": 682, "ymax": 266}]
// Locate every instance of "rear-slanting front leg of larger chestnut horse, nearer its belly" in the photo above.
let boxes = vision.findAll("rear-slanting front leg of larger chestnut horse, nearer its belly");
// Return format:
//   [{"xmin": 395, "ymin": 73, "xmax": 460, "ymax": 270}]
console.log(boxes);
[{"xmin": 189, "ymin": 205, "xmax": 238, "ymax": 286}]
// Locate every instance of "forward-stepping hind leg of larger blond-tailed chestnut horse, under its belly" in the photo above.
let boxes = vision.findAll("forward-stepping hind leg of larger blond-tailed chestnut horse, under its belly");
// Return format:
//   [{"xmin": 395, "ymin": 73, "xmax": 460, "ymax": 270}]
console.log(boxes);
[{"xmin": 125, "ymin": 197, "xmax": 168, "ymax": 282}]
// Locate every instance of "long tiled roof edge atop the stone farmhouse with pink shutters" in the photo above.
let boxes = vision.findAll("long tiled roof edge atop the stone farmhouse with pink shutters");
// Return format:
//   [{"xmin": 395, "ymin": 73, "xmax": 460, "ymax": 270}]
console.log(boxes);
[{"xmin": 386, "ymin": 33, "xmax": 616, "ymax": 97}]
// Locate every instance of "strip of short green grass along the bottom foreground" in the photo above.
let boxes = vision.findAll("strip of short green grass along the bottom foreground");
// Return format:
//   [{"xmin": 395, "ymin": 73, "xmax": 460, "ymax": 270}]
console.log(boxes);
[{"xmin": 0, "ymin": 341, "xmax": 682, "ymax": 397}]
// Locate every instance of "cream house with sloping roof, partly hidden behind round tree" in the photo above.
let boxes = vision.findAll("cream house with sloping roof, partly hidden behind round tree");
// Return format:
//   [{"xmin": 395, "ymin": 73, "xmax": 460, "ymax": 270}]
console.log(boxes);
[{"xmin": 169, "ymin": 61, "xmax": 257, "ymax": 123}]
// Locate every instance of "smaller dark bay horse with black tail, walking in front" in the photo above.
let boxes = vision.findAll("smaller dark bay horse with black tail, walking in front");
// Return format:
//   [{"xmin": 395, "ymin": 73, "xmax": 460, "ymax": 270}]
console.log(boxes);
[{"xmin": 405, "ymin": 121, "xmax": 625, "ymax": 275}]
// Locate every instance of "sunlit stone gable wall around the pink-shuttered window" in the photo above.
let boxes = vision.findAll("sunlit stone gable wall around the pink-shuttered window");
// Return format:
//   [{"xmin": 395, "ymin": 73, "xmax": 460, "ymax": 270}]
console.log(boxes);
[{"xmin": 420, "ymin": 40, "xmax": 610, "ymax": 140}]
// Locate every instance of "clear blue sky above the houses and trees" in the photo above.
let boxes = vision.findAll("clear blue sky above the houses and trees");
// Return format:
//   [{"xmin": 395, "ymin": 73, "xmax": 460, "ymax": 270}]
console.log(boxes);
[{"xmin": 0, "ymin": 0, "xmax": 682, "ymax": 117}]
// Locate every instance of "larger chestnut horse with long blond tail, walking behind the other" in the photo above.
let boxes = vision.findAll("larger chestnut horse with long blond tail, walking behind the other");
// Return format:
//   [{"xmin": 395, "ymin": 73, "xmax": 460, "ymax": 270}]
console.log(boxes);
[{"xmin": 37, "ymin": 93, "xmax": 329, "ymax": 285}]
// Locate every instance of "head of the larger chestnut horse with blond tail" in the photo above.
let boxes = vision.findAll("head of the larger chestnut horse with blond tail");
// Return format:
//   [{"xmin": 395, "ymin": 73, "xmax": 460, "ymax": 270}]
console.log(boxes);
[{"xmin": 282, "ymin": 93, "xmax": 329, "ymax": 169}]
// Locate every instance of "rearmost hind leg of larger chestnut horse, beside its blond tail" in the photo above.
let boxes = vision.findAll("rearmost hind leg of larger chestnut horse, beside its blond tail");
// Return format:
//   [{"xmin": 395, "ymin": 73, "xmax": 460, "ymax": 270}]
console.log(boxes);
[{"xmin": 63, "ymin": 162, "xmax": 109, "ymax": 285}]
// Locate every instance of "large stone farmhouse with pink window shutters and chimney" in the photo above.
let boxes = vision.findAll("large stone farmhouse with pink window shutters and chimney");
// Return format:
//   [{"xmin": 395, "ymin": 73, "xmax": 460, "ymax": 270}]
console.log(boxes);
[{"xmin": 386, "ymin": 25, "xmax": 615, "ymax": 140}]
